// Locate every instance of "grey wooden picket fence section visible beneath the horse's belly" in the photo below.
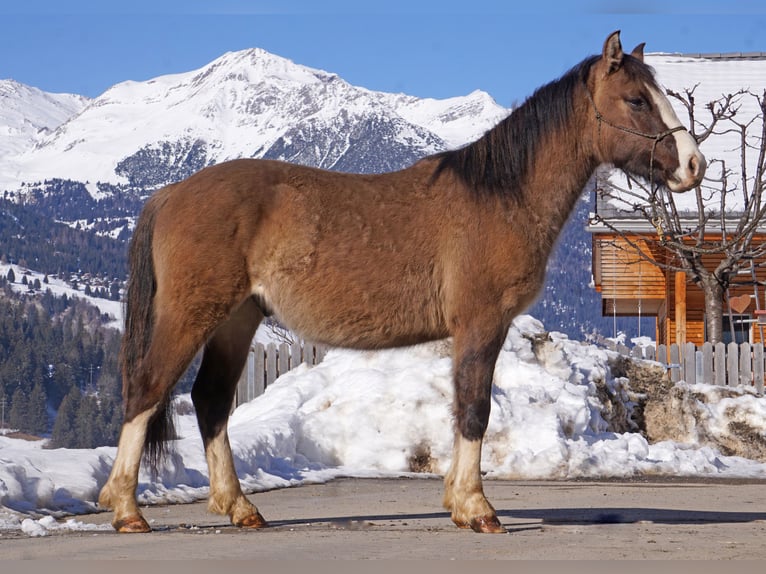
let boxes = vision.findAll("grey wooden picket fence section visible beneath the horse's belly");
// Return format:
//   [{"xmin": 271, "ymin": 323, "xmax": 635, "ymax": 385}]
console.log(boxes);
[{"xmin": 234, "ymin": 341, "xmax": 327, "ymax": 406}]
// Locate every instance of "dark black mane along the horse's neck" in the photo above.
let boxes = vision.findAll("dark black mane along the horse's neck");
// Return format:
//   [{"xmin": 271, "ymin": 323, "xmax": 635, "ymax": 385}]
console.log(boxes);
[{"xmin": 434, "ymin": 56, "xmax": 599, "ymax": 200}]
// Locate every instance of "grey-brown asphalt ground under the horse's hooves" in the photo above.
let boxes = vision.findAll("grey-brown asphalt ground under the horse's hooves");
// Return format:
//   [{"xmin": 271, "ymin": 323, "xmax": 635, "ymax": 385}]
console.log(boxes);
[{"xmin": 0, "ymin": 478, "xmax": 766, "ymax": 572}]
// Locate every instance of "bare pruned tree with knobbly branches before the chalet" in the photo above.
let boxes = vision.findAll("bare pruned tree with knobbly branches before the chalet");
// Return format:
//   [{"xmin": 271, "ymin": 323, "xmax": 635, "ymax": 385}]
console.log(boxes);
[{"xmin": 593, "ymin": 86, "xmax": 766, "ymax": 343}]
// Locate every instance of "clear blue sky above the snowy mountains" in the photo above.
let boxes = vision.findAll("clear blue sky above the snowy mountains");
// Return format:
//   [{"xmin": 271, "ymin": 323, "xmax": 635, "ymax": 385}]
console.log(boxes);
[{"xmin": 0, "ymin": 0, "xmax": 766, "ymax": 106}]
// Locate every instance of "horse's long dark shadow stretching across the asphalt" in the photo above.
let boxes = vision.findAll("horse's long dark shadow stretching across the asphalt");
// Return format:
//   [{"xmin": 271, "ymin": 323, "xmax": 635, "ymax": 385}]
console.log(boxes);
[{"xmin": 270, "ymin": 507, "xmax": 766, "ymax": 532}]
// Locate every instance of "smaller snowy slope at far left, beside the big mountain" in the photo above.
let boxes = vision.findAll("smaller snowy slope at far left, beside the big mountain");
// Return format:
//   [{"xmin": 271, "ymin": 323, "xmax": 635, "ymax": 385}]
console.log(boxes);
[{"xmin": 0, "ymin": 80, "xmax": 90, "ymax": 161}]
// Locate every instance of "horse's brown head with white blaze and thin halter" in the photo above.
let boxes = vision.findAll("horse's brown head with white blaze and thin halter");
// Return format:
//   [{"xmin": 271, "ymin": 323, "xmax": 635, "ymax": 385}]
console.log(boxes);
[{"xmin": 586, "ymin": 31, "xmax": 706, "ymax": 191}]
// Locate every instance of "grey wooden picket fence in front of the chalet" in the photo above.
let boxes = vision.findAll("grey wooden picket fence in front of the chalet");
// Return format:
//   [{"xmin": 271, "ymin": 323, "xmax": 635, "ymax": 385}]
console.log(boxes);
[{"xmin": 605, "ymin": 343, "xmax": 766, "ymax": 394}]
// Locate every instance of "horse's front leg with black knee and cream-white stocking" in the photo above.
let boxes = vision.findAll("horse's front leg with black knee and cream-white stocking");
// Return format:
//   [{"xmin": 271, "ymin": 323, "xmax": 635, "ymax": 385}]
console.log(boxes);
[{"xmin": 444, "ymin": 330, "xmax": 506, "ymax": 533}]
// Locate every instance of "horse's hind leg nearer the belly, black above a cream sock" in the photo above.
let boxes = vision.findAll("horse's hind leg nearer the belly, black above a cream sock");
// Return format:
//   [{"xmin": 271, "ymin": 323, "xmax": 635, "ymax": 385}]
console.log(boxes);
[{"xmin": 192, "ymin": 299, "xmax": 266, "ymax": 528}]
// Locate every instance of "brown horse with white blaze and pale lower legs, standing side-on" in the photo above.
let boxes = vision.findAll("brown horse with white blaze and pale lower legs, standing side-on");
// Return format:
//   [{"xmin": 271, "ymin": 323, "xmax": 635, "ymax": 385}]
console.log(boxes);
[{"xmin": 99, "ymin": 32, "xmax": 705, "ymax": 532}]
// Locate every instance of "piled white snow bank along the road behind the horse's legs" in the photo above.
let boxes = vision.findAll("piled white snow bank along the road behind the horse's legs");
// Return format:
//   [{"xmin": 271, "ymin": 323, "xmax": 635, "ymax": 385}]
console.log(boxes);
[{"xmin": 0, "ymin": 316, "xmax": 766, "ymax": 534}]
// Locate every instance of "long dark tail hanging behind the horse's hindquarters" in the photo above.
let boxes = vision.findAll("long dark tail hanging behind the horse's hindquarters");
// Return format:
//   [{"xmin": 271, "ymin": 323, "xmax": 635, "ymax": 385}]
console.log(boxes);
[{"xmin": 120, "ymin": 199, "xmax": 175, "ymax": 470}]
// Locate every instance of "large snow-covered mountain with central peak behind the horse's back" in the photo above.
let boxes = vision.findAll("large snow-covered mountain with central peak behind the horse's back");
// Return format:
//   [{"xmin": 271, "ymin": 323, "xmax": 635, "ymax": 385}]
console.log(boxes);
[{"xmin": 0, "ymin": 49, "xmax": 508, "ymax": 196}]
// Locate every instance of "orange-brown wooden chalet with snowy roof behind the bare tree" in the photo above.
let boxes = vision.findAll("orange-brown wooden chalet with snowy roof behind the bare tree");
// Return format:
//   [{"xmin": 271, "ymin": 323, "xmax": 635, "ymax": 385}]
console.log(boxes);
[{"xmin": 588, "ymin": 53, "xmax": 766, "ymax": 345}]
